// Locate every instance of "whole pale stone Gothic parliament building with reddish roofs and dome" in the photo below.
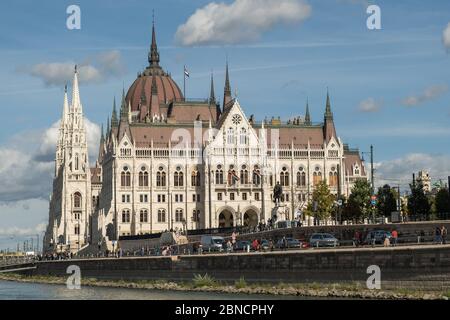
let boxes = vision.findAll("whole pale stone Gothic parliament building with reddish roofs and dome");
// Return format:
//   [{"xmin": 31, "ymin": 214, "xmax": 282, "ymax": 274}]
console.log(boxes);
[{"xmin": 44, "ymin": 21, "xmax": 367, "ymax": 251}]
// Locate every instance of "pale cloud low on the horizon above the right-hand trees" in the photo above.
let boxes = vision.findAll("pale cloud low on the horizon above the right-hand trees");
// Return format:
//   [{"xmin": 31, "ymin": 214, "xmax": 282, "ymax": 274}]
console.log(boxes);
[{"xmin": 369, "ymin": 153, "xmax": 450, "ymax": 189}]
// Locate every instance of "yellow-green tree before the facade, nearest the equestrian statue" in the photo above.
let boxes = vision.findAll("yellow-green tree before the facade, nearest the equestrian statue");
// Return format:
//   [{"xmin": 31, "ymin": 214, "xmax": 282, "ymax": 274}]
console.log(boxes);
[{"xmin": 306, "ymin": 180, "xmax": 335, "ymax": 220}]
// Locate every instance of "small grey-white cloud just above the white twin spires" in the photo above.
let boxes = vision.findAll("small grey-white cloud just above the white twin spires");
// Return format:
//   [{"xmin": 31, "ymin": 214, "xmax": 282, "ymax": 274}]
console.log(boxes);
[{"xmin": 26, "ymin": 50, "xmax": 125, "ymax": 86}]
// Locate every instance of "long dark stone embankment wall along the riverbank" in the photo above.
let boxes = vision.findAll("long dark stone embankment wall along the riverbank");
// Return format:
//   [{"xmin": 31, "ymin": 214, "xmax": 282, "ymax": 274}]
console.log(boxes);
[{"xmin": 24, "ymin": 245, "xmax": 450, "ymax": 290}]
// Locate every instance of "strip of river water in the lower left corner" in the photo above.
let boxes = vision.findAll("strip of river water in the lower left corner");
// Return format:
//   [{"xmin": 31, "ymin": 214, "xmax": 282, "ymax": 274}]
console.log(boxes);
[{"xmin": 0, "ymin": 280, "xmax": 305, "ymax": 300}]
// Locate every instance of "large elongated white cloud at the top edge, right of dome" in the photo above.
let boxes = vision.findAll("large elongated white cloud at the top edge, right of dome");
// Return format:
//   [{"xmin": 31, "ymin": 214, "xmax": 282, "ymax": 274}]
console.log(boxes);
[{"xmin": 175, "ymin": 0, "xmax": 312, "ymax": 46}]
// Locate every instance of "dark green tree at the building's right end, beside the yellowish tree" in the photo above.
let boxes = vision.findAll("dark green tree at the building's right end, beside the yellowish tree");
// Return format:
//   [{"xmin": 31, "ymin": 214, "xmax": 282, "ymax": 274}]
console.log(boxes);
[{"xmin": 344, "ymin": 180, "xmax": 372, "ymax": 221}]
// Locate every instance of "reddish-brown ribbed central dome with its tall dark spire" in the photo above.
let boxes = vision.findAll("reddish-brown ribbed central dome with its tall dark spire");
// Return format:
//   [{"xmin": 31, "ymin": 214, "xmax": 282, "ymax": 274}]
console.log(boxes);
[{"xmin": 126, "ymin": 26, "xmax": 184, "ymax": 112}]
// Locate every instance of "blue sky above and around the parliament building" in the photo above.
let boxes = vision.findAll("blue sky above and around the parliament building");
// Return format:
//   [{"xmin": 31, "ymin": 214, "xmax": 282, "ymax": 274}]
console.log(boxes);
[{"xmin": 0, "ymin": 0, "xmax": 450, "ymax": 247}]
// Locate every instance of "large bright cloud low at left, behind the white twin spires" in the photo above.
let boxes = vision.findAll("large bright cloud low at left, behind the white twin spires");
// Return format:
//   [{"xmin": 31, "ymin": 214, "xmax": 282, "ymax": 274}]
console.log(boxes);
[{"xmin": 0, "ymin": 119, "xmax": 100, "ymax": 203}]
